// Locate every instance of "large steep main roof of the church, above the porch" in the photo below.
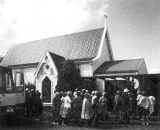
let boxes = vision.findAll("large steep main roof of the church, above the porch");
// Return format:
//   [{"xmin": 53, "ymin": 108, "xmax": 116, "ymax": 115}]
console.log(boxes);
[{"xmin": 2, "ymin": 28, "xmax": 104, "ymax": 66}]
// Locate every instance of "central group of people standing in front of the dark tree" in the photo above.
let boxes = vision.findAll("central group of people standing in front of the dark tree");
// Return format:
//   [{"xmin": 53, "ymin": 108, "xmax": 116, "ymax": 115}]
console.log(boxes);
[{"xmin": 52, "ymin": 89, "xmax": 108, "ymax": 125}]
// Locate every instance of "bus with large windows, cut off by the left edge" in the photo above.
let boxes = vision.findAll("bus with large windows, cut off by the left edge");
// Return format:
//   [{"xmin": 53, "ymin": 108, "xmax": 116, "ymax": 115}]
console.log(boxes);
[{"xmin": 0, "ymin": 66, "xmax": 25, "ymax": 117}]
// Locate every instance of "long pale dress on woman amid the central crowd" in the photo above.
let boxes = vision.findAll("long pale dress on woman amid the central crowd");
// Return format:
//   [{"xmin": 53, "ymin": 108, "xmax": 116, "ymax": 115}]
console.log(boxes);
[{"xmin": 81, "ymin": 98, "xmax": 91, "ymax": 119}]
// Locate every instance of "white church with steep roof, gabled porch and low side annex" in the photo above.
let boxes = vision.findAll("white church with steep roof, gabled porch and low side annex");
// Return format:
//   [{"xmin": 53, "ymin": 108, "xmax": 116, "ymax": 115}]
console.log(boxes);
[{"xmin": 1, "ymin": 19, "xmax": 148, "ymax": 105}]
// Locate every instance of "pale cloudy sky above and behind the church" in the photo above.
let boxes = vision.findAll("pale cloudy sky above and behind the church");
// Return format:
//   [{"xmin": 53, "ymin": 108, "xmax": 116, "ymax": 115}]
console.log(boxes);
[{"xmin": 0, "ymin": 0, "xmax": 160, "ymax": 73}]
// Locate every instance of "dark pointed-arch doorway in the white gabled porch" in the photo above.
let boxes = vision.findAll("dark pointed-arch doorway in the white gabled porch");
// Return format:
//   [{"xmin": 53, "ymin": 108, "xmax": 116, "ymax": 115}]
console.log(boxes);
[{"xmin": 42, "ymin": 77, "xmax": 51, "ymax": 103}]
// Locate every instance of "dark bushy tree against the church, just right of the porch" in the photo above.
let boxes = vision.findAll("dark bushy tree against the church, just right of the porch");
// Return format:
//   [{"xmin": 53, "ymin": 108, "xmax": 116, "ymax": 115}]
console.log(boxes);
[{"xmin": 55, "ymin": 60, "xmax": 82, "ymax": 92}]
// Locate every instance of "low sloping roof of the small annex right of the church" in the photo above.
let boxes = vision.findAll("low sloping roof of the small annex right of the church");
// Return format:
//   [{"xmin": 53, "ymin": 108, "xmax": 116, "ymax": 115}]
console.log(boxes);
[{"xmin": 94, "ymin": 59, "xmax": 144, "ymax": 74}]
